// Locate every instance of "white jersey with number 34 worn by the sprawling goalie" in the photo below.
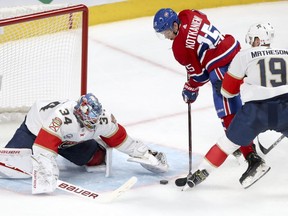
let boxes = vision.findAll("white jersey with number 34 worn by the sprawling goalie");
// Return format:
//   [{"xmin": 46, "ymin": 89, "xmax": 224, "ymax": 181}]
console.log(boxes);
[{"xmin": 26, "ymin": 100, "xmax": 126, "ymax": 153}]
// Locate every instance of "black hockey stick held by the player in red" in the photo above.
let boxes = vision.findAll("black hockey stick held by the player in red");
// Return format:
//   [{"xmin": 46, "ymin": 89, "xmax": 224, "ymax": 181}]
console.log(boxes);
[{"xmin": 175, "ymin": 103, "xmax": 192, "ymax": 187}]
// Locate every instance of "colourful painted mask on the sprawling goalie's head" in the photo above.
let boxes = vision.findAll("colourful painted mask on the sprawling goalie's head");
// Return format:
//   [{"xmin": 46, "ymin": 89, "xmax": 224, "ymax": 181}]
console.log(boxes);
[{"xmin": 74, "ymin": 93, "xmax": 102, "ymax": 130}]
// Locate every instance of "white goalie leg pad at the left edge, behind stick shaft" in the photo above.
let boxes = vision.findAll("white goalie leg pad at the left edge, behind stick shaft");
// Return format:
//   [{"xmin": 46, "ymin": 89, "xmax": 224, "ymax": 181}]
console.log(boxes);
[{"xmin": 0, "ymin": 148, "xmax": 32, "ymax": 179}]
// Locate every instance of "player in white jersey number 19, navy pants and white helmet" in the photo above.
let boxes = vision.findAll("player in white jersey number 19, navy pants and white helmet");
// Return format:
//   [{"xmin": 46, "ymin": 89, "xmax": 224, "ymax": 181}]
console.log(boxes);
[{"xmin": 185, "ymin": 23, "xmax": 288, "ymax": 188}]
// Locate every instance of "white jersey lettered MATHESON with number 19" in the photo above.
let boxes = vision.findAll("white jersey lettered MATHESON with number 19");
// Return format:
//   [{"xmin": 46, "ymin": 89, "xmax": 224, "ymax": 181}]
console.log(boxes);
[{"xmin": 222, "ymin": 46, "xmax": 288, "ymax": 103}]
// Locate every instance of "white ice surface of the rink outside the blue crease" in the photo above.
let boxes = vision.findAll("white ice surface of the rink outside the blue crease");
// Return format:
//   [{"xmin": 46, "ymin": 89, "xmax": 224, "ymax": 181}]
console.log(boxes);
[{"xmin": 0, "ymin": 1, "xmax": 288, "ymax": 216}]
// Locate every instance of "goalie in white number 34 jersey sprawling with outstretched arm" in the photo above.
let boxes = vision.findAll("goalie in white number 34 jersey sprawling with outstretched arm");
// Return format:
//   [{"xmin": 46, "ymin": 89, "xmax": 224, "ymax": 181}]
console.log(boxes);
[{"xmin": 0, "ymin": 93, "xmax": 168, "ymax": 194}]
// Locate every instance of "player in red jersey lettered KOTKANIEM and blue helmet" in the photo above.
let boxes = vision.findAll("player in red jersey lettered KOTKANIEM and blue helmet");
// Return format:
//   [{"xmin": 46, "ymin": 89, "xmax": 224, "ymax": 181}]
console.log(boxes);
[{"xmin": 153, "ymin": 8, "xmax": 261, "ymax": 186}]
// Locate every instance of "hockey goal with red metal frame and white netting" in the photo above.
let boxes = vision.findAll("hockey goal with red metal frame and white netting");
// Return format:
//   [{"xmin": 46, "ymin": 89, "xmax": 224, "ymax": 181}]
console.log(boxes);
[{"xmin": 0, "ymin": 5, "xmax": 88, "ymax": 122}]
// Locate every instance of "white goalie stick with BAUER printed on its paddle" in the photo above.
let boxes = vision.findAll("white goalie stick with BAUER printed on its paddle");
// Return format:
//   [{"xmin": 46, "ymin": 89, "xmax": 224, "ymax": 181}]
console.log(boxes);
[{"xmin": 0, "ymin": 162, "xmax": 137, "ymax": 203}]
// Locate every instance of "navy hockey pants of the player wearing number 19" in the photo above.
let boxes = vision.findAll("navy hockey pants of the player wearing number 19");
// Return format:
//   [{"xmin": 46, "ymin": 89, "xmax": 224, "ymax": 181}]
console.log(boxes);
[{"xmin": 226, "ymin": 94, "xmax": 288, "ymax": 146}]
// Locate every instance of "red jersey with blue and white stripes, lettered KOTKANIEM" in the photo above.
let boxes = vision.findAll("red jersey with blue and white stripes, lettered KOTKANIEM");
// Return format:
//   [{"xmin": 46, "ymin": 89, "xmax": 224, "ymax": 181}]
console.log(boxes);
[{"xmin": 172, "ymin": 10, "xmax": 240, "ymax": 87}]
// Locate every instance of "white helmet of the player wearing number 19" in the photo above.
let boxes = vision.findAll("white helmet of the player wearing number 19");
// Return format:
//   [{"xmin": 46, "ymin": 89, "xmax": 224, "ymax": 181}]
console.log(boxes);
[{"xmin": 245, "ymin": 23, "xmax": 274, "ymax": 46}]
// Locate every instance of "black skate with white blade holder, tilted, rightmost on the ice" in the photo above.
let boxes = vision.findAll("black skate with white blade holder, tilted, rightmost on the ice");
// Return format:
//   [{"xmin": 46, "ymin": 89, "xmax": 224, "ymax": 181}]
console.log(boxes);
[{"xmin": 239, "ymin": 152, "xmax": 270, "ymax": 189}]
